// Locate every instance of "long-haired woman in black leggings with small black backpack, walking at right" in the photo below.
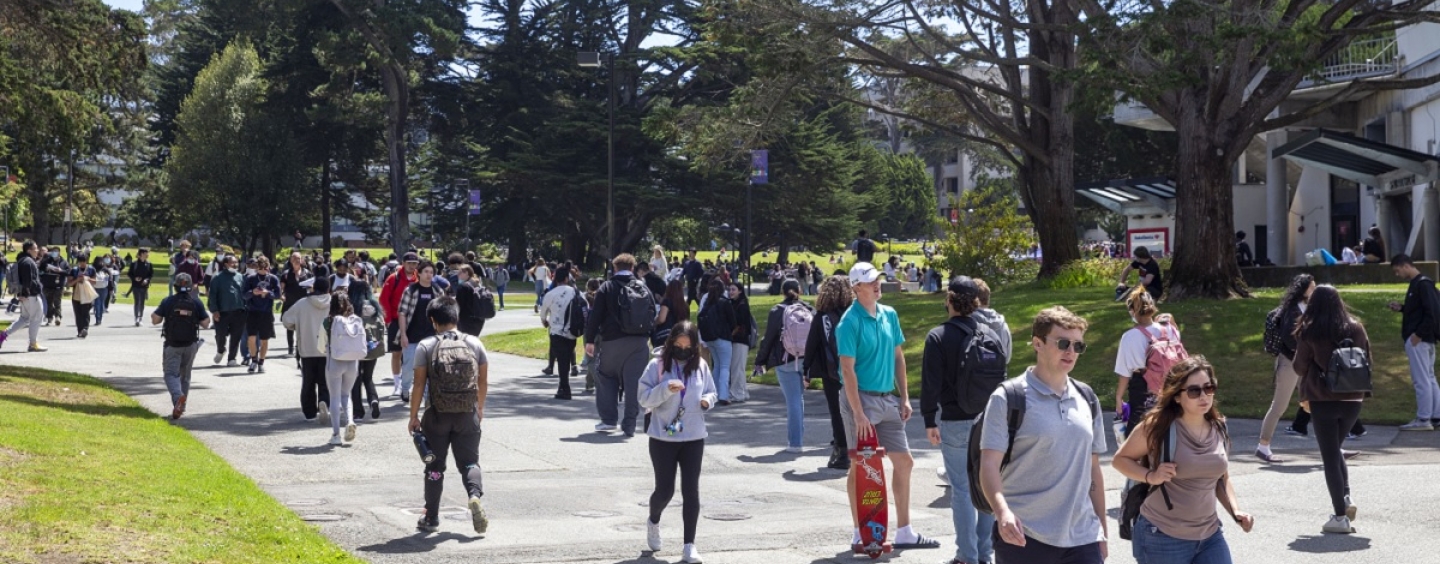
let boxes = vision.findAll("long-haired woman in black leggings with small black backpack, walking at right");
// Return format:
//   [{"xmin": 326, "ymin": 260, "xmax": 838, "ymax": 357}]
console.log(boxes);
[{"xmin": 1295, "ymin": 285, "xmax": 1374, "ymax": 534}]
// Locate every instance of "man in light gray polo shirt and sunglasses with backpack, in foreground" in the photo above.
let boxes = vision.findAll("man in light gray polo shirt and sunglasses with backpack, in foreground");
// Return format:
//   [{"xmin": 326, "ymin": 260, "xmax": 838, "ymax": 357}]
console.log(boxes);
[{"xmin": 981, "ymin": 306, "xmax": 1109, "ymax": 564}]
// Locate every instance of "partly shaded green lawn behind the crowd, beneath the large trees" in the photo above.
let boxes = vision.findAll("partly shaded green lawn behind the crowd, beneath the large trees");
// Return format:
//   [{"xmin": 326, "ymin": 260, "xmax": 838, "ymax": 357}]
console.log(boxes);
[{"xmin": 485, "ymin": 285, "xmax": 1416, "ymax": 423}]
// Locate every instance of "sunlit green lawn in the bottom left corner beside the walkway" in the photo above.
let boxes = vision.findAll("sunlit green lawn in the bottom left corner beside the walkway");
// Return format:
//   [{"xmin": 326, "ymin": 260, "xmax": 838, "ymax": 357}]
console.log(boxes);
[{"xmin": 0, "ymin": 367, "xmax": 361, "ymax": 564}]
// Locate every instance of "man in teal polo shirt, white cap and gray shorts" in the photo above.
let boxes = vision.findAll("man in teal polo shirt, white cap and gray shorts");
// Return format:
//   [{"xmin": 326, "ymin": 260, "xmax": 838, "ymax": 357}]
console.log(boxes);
[{"xmin": 835, "ymin": 262, "xmax": 940, "ymax": 548}]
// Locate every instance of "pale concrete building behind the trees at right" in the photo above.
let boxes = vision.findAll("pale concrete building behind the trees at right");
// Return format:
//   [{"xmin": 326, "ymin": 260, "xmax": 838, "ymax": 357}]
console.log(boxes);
[{"xmin": 1105, "ymin": 23, "xmax": 1440, "ymax": 265}]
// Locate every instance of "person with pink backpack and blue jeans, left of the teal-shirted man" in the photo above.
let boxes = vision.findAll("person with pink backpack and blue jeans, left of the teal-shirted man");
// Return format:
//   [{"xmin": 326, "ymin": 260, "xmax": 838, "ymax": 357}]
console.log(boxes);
[{"xmin": 754, "ymin": 281, "xmax": 815, "ymax": 453}]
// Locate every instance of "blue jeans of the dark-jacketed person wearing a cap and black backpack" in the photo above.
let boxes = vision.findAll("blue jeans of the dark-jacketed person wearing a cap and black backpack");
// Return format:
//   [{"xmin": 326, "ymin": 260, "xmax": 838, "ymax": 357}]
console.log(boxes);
[{"xmin": 937, "ymin": 419, "xmax": 995, "ymax": 563}]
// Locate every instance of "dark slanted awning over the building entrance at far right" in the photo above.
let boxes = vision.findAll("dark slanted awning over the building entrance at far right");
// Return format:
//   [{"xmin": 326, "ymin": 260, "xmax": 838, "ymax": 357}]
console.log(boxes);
[{"xmin": 1270, "ymin": 129, "xmax": 1440, "ymax": 188}]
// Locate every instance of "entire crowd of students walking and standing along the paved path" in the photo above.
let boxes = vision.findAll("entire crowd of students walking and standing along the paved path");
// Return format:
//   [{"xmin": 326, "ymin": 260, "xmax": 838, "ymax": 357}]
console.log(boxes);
[{"xmin": 0, "ymin": 235, "xmax": 1440, "ymax": 564}]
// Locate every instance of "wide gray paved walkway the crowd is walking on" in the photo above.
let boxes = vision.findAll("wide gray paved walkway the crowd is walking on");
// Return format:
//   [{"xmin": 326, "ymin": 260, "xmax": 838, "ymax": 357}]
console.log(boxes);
[{"xmin": 0, "ymin": 308, "xmax": 1440, "ymax": 564}]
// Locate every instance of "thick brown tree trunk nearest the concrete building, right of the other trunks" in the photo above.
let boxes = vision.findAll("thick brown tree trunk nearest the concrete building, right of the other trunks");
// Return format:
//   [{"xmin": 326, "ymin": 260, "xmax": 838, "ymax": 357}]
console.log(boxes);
[{"xmin": 1165, "ymin": 115, "xmax": 1250, "ymax": 301}]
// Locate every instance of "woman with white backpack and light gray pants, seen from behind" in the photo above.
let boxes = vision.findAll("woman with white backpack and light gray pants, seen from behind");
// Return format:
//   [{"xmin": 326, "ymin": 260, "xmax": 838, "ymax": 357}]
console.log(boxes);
[{"xmin": 325, "ymin": 289, "xmax": 369, "ymax": 446}]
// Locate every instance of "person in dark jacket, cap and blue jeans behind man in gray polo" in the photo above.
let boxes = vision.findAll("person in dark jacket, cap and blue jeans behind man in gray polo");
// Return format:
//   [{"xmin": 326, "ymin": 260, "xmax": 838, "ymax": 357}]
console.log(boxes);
[{"xmin": 920, "ymin": 276, "xmax": 1009, "ymax": 564}]
